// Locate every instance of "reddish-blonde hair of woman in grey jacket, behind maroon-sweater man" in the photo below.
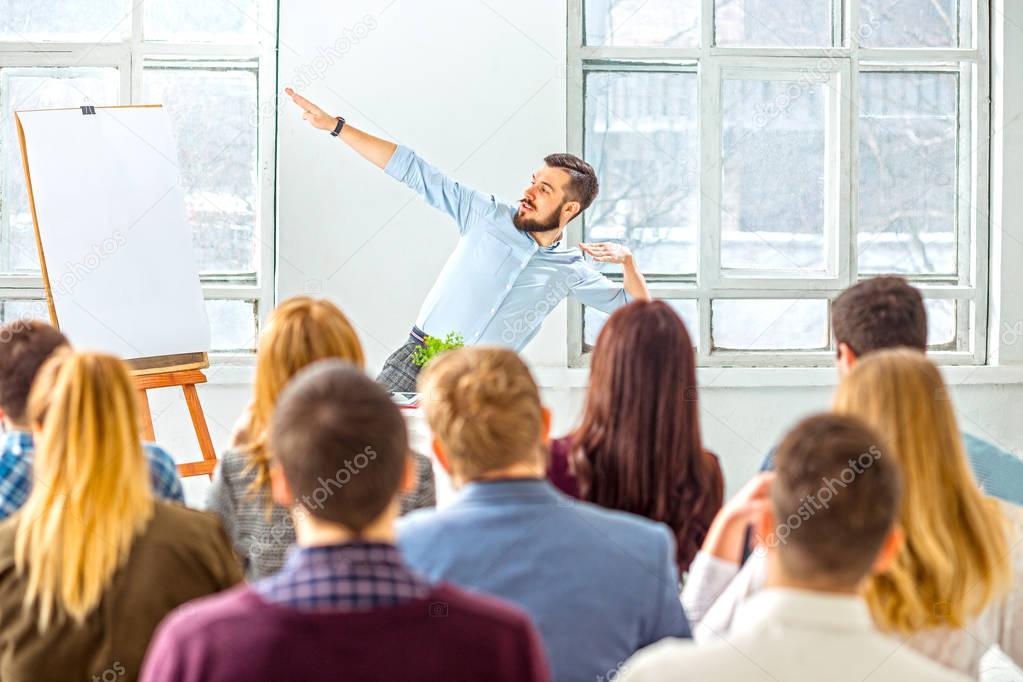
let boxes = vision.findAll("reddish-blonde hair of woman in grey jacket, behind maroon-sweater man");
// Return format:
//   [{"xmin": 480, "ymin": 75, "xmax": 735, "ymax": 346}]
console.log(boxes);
[{"xmin": 234, "ymin": 297, "xmax": 365, "ymax": 493}]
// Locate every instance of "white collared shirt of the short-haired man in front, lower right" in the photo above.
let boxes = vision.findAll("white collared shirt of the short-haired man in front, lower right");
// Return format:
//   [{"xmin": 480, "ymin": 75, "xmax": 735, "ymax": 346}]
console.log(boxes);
[{"xmin": 618, "ymin": 588, "xmax": 970, "ymax": 682}]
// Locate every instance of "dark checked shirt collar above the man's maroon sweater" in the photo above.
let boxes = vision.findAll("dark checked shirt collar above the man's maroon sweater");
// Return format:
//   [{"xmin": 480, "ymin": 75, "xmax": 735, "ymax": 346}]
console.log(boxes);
[{"xmin": 253, "ymin": 542, "xmax": 432, "ymax": 611}]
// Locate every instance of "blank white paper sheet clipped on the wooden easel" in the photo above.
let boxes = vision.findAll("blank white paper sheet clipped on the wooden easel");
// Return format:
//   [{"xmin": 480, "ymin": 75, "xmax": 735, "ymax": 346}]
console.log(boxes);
[{"xmin": 17, "ymin": 107, "xmax": 210, "ymax": 359}]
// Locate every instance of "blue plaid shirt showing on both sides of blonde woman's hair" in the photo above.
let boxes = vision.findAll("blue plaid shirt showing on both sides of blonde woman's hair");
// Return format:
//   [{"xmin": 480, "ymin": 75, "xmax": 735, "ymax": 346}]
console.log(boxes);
[{"xmin": 0, "ymin": 431, "xmax": 185, "ymax": 518}]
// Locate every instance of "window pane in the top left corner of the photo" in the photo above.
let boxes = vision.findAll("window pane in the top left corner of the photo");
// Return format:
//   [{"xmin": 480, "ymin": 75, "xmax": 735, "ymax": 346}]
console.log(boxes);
[{"xmin": 0, "ymin": 0, "xmax": 131, "ymax": 42}]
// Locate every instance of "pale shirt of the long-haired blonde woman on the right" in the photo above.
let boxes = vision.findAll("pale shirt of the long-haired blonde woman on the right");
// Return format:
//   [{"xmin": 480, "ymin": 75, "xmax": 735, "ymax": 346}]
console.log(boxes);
[{"xmin": 682, "ymin": 502, "xmax": 1023, "ymax": 679}]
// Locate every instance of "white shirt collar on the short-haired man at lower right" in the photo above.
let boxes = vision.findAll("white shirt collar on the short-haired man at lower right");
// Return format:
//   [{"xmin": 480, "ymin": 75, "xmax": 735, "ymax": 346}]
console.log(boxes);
[{"xmin": 736, "ymin": 588, "xmax": 875, "ymax": 631}]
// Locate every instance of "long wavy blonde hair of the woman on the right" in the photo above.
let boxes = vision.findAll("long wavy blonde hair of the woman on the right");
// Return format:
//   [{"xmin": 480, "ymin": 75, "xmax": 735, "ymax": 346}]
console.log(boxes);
[{"xmin": 834, "ymin": 349, "xmax": 1011, "ymax": 634}]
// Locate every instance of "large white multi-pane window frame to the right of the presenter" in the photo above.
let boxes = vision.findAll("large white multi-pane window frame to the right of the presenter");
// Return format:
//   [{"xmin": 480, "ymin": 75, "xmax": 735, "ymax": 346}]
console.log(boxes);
[{"xmin": 567, "ymin": 0, "xmax": 991, "ymax": 367}]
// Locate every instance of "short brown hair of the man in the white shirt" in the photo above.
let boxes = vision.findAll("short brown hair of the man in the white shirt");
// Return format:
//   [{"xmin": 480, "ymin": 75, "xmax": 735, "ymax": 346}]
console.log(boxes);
[{"xmin": 767, "ymin": 414, "xmax": 902, "ymax": 587}]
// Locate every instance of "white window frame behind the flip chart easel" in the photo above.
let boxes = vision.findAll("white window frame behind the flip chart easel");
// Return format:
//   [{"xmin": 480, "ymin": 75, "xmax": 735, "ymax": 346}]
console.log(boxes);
[{"xmin": 0, "ymin": 0, "xmax": 278, "ymax": 351}]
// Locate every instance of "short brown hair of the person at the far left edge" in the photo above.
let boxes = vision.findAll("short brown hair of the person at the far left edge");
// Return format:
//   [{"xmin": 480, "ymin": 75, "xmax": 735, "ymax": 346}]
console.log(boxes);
[{"xmin": 0, "ymin": 320, "xmax": 69, "ymax": 423}]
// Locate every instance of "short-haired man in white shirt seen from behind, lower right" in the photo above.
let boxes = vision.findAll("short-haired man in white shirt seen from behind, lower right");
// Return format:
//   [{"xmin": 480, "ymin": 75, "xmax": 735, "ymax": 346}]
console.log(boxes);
[{"xmin": 621, "ymin": 415, "xmax": 970, "ymax": 682}]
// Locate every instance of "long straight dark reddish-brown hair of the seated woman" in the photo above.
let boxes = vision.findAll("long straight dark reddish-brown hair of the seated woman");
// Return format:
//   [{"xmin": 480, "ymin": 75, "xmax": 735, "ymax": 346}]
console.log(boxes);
[{"xmin": 547, "ymin": 301, "xmax": 724, "ymax": 574}]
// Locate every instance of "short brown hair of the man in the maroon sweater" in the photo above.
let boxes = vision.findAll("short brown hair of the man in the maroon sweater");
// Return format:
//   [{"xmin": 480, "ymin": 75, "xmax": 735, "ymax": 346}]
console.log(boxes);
[{"xmin": 269, "ymin": 360, "xmax": 408, "ymax": 533}]
